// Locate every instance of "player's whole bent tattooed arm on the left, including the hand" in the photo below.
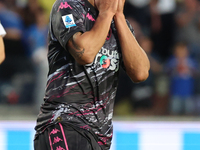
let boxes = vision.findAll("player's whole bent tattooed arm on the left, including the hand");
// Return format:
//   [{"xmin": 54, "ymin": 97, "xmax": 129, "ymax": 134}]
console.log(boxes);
[{"xmin": 67, "ymin": 0, "xmax": 117, "ymax": 65}]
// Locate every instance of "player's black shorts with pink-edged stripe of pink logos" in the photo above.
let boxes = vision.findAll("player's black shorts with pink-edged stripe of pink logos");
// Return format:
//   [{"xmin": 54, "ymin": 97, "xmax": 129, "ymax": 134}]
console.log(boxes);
[{"xmin": 34, "ymin": 123, "xmax": 102, "ymax": 150}]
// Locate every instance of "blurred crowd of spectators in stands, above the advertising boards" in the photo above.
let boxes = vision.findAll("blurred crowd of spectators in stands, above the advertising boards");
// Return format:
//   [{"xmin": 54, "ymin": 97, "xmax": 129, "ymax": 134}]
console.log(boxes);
[{"xmin": 0, "ymin": 0, "xmax": 200, "ymax": 115}]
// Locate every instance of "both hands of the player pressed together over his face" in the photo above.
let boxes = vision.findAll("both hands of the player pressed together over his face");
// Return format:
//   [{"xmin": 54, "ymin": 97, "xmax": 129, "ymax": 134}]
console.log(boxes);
[{"xmin": 95, "ymin": 0, "xmax": 125, "ymax": 15}]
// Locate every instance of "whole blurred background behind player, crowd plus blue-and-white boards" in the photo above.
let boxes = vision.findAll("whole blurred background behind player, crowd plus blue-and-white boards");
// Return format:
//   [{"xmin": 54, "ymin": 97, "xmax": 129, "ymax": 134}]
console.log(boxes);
[{"xmin": 0, "ymin": 0, "xmax": 200, "ymax": 150}]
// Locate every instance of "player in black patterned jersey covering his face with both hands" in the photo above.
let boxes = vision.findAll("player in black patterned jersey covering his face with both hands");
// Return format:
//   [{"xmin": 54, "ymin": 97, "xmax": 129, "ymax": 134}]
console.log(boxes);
[{"xmin": 34, "ymin": 0, "xmax": 149, "ymax": 150}]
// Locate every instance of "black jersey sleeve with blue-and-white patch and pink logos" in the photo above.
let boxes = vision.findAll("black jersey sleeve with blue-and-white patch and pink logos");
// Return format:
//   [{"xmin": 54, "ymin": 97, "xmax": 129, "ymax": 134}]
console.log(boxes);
[{"xmin": 50, "ymin": 1, "xmax": 85, "ymax": 49}]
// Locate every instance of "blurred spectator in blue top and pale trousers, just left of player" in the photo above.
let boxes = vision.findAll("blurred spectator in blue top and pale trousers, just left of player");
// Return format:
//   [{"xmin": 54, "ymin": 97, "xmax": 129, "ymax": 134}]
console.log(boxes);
[{"xmin": 24, "ymin": 7, "xmax": 48, "ymax": 112}]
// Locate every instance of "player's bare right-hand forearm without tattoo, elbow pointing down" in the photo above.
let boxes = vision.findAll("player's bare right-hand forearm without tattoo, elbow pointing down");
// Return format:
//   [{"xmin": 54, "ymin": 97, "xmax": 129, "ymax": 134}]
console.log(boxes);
[{"xmin": 114, "ymin": 13, "xmax": 150, "ymax": 82}]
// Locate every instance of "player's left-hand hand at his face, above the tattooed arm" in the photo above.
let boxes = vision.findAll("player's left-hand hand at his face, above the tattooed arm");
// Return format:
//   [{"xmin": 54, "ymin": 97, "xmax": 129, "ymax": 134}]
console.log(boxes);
[{"xmin": 94, "ymin": 0, "xmax": 119, "ymax": 15}]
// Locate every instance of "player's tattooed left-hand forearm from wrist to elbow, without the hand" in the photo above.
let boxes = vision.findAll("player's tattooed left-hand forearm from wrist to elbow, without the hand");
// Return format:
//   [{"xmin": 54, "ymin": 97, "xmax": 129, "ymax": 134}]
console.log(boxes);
[{"xmin": 68, "ymin": 13, "xmax": 114, "ymax": 65}]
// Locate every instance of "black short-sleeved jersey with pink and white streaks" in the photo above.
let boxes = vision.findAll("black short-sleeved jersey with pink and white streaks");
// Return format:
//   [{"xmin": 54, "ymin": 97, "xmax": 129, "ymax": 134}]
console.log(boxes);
[{"xmin": 35, "ymin": 0, "xmax": 133, "ymax": 150}]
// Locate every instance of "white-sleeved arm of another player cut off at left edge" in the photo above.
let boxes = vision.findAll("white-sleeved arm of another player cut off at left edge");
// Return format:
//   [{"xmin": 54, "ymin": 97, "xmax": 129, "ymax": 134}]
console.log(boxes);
[{"xmin": 0, "ymin": 23, "xmax": 6, "ymax": 64}]
